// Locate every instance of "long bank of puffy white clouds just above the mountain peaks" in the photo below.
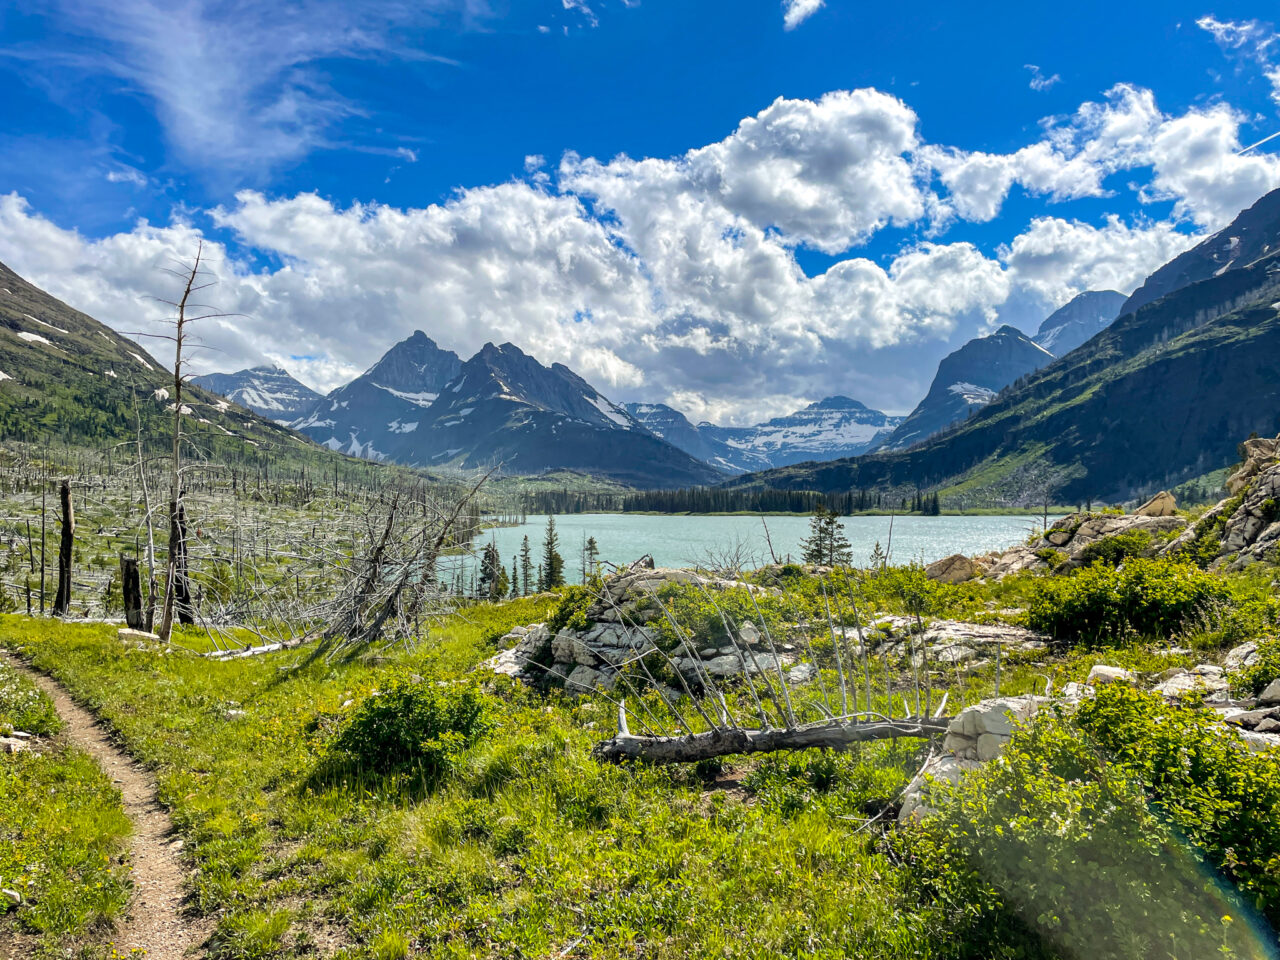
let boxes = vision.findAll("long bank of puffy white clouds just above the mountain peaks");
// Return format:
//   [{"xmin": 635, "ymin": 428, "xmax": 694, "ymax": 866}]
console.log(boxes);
[{"xmin": 0, "ymin": 84, "xmax": 1280, "ymax": 422}]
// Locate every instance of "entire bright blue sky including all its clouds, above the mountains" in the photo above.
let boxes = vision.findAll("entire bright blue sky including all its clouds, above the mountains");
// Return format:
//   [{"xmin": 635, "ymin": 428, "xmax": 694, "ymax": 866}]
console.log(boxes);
[{"xmin": 0, "ymin": 0, "xmax": 1280, "ymax": 421}]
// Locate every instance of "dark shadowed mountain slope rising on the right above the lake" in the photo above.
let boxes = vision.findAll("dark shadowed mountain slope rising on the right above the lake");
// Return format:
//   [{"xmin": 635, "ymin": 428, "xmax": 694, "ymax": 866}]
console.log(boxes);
[{"xmin": 730, "ymin": 191, "xmax": 1280, "ymax": 503}]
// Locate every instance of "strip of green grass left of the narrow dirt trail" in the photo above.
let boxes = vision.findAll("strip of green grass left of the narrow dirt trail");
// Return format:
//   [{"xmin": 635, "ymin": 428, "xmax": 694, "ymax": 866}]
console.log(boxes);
[{"xmin": 0, "ymin": 663, "xmax": 131, "ymax": 956}]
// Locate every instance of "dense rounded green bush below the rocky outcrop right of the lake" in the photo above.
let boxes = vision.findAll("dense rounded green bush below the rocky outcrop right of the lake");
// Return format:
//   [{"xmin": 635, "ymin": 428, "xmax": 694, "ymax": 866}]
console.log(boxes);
[{"xmin": 1027, "ymin": 559, "xmax": 1229, "ymax": 645}]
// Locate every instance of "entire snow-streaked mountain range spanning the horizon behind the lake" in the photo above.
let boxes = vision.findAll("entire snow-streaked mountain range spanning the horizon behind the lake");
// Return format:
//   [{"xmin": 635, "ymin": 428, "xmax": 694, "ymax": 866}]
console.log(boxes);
[{"xmin": 15, "ymin": 183, "xmax": 1280, "ymax": 503}]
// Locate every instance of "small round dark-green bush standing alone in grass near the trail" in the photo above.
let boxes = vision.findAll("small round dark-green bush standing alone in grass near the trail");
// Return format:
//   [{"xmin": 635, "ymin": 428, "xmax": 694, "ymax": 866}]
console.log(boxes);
[{"xmin": 329, "ymin": 677, "xmax": 492, "ymax": 780}]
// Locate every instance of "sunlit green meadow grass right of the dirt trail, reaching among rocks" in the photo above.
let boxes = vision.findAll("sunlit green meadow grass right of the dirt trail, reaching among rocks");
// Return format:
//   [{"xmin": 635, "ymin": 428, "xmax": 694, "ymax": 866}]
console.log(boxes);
[{"xmin": 0, "ymin": 555, "xmax": 1263, "ymax": 960}]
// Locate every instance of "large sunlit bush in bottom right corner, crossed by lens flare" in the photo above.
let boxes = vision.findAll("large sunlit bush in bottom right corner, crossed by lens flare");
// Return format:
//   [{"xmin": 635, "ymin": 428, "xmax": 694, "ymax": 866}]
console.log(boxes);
[{"xmin": 892, "ymin": 690, "xmax": 1271, "ymax": 960}]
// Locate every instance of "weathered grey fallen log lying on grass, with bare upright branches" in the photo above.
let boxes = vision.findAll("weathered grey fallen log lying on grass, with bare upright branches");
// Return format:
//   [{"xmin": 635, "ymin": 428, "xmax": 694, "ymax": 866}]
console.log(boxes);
[{"xmin": 593, "ymin": 717, "xmax": 951, "ymax": 763}]
